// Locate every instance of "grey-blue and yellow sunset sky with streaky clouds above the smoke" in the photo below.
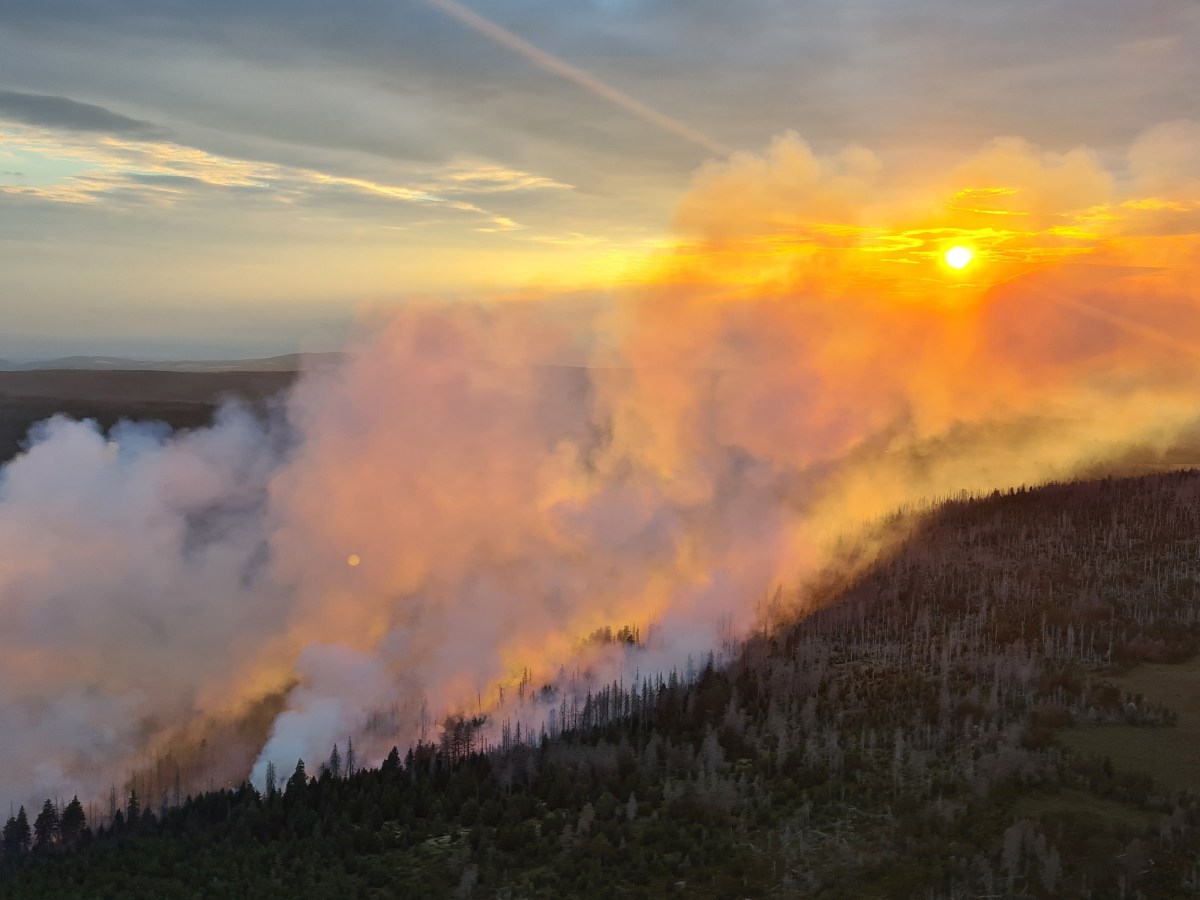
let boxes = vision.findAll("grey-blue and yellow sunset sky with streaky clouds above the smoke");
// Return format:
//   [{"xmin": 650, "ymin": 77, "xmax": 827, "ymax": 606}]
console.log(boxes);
[{"xmin": 0, "ymin": 0, "xmax": 1200, "ymax": 359}]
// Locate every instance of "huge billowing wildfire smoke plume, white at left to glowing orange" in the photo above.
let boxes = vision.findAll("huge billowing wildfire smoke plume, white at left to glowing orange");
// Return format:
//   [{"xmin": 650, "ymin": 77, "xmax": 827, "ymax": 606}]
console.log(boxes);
[{"xmin": 0, "ymin": 122, "xmax": 1200, "ymax": 805}]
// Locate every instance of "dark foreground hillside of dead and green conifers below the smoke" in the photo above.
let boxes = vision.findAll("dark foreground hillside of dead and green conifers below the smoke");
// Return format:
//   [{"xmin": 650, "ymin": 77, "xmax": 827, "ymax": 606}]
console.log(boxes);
[{"xmin": 0, "ymin": 472, "xmax": 1200, "ymax": 899}]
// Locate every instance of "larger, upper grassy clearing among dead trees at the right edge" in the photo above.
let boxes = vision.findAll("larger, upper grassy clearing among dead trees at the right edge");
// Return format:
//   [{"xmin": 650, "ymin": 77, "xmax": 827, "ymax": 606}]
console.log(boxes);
[{"xmin": 1058, "ymin": 656, "xmax": 1200, "ymax": 792}]
